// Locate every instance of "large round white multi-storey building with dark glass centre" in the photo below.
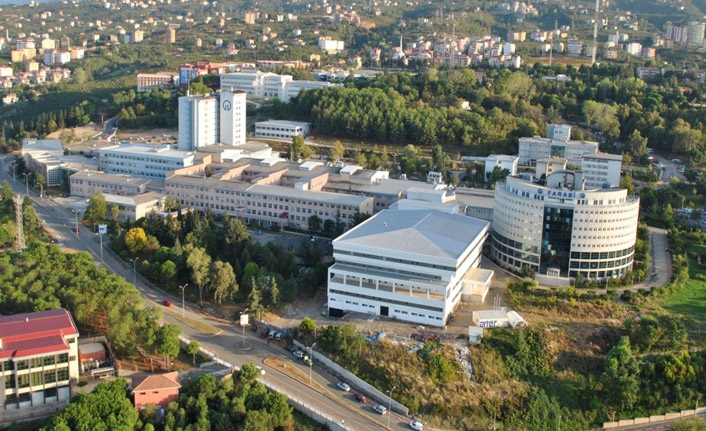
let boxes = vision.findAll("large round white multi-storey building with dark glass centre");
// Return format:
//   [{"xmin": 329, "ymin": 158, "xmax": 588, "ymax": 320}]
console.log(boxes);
[{"xmin": 491, "ymin": 170, "xmax": 640, "ymax": 280}]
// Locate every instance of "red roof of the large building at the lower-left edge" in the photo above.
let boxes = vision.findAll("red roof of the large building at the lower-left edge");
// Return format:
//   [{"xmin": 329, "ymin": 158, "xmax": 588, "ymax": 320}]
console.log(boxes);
[{"xmin": 0, "ymin": 308, "xmax": 78, "ymax": 359}]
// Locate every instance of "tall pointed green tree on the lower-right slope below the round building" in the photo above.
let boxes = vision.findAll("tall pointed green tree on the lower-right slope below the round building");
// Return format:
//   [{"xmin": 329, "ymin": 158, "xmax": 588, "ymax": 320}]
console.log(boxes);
[{"xmin": 602, "ymin": 336, "xmax": 640, "ymax": 411}]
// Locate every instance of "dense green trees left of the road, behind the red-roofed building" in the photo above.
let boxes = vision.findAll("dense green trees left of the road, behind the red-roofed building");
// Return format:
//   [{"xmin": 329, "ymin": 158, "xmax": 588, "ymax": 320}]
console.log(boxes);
[{"xmin": 0, "ymin": 243, "xmax": 160, "ymax": 355}]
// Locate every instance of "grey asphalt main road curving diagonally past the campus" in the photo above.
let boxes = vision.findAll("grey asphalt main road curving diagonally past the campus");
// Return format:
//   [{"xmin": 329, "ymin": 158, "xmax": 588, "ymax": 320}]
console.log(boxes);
[{"xmin": 0, "ymin": 156, "xmax": 409, "ymax": 431}]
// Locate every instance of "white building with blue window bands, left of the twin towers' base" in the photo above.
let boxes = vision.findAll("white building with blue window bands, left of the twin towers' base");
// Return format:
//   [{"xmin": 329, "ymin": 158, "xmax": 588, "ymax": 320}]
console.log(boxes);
[{"xmin": 98, "ymin": 144, "xmax": 194, "ymax": 180}]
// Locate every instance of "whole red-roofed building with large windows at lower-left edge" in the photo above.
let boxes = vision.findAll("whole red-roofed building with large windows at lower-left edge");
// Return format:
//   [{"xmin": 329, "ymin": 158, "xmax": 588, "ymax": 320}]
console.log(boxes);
[{"xmin": 0, "ymin": 309, "xmax": 79, "ymax": 411}]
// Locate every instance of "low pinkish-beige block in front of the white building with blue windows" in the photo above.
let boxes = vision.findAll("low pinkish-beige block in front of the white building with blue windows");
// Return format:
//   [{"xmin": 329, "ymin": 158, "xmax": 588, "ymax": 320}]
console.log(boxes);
[{"xmin": 69, "ymin": 170, "xmax": 150, "ymax": 198}]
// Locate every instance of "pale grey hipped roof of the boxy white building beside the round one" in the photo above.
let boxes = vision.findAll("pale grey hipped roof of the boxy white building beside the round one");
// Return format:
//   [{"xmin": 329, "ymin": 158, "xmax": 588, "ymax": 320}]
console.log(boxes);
[{"xmin": 333, "ymin": 210, "xmax": 489, "ymax": 260}]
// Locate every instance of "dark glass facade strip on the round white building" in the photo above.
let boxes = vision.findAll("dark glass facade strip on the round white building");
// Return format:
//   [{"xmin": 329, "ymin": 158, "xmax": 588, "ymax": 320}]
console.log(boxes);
[{"xmin": 539, "ymin": 206, "xmax": 574, "ymax": 277}]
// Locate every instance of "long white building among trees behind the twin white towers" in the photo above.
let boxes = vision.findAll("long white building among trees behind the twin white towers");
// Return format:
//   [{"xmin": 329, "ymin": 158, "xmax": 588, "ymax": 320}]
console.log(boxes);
[{"xmin": 221, "ymin": 70, "xmax": 337, "ymax": 103}]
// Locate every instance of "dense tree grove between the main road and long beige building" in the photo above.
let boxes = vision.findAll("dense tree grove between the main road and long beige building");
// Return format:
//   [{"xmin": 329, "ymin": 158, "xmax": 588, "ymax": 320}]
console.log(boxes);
[{"xmin": 111, "ymin": 211, "xmax": 327, "ymax": 312}]
